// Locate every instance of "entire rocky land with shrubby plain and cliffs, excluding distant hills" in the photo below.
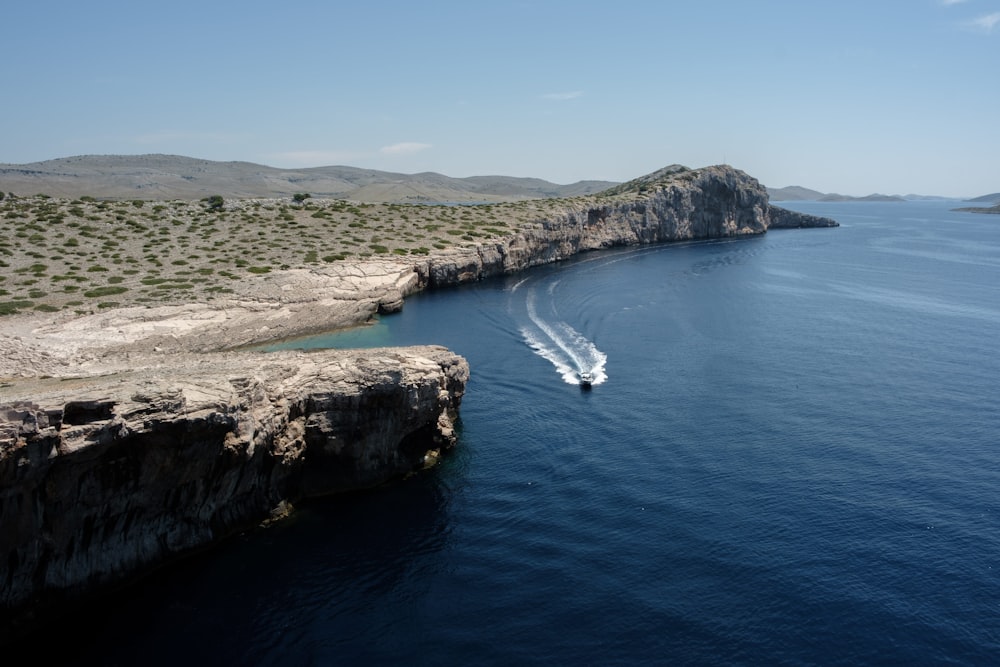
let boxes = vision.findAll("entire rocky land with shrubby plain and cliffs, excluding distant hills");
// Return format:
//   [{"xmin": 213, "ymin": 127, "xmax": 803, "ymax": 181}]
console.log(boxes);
[{"xmin": 0, "ymin": 159, "xmax": 837, "ymax": 640}]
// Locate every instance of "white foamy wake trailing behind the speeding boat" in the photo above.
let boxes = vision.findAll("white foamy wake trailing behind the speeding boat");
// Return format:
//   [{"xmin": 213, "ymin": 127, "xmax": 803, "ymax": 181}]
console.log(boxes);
[{"xmin": 515, "ymin": 283, "xmax": 608, "ymax": 385}]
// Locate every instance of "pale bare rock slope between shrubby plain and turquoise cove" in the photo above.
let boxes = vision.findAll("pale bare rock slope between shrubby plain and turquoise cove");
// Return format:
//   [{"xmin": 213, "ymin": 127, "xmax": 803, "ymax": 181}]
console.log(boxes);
[{"xmin": 0, "ymin": 260, "xmax": 426, "ymax": 380}]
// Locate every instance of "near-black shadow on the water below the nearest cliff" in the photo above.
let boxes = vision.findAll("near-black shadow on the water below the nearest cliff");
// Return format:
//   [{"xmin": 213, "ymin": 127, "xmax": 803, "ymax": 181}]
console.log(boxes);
[{"xmin": 7, "ymin": 464, "xmax": 461, "ymax": 665}]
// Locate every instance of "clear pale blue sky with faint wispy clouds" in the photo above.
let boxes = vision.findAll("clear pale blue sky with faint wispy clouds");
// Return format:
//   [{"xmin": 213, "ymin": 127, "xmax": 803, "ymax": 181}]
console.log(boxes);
[{"xmin": 0, "ymin": 0, "xmax": 1000, "ymax": 197}]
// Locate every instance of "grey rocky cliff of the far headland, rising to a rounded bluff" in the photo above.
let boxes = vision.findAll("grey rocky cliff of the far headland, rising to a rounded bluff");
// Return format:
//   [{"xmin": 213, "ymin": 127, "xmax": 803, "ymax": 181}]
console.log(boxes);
[{"xmin": 418, "ymin": 166, "xmax": 837, "ymax": 287}]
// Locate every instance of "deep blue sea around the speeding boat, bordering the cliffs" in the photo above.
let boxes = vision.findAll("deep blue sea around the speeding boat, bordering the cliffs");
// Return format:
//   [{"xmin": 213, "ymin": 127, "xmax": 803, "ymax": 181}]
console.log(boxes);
[{"xmin": 39, "ymin": 202, "xmax": 1000, "ymax": 665}]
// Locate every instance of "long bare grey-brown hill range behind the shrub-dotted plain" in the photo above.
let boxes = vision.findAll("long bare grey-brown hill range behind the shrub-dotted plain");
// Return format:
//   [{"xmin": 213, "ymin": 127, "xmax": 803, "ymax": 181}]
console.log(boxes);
[{"xmin": 0, "ymin": 155, "xmax": 616, "ymax": 203}]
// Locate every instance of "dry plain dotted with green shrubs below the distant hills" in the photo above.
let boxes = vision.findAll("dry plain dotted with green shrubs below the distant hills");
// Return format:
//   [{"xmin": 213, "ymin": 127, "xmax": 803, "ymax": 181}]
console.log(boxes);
[{"xmin": 0, "ymin": 195, "xmax": 580, "ymax": 314}]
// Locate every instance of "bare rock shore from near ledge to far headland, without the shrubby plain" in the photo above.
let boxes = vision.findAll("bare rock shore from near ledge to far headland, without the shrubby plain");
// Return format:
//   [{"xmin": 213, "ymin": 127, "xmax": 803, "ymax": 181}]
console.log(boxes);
[{"xmin": 0, "ymin": 167, "xmax": 837, "ymax": 636}]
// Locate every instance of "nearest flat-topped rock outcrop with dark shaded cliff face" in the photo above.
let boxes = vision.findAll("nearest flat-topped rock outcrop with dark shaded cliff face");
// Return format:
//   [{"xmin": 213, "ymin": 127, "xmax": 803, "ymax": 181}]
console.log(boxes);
[{"xmin": 0, "ymin": 347, "xmax": 469, "ymax": 639}]
